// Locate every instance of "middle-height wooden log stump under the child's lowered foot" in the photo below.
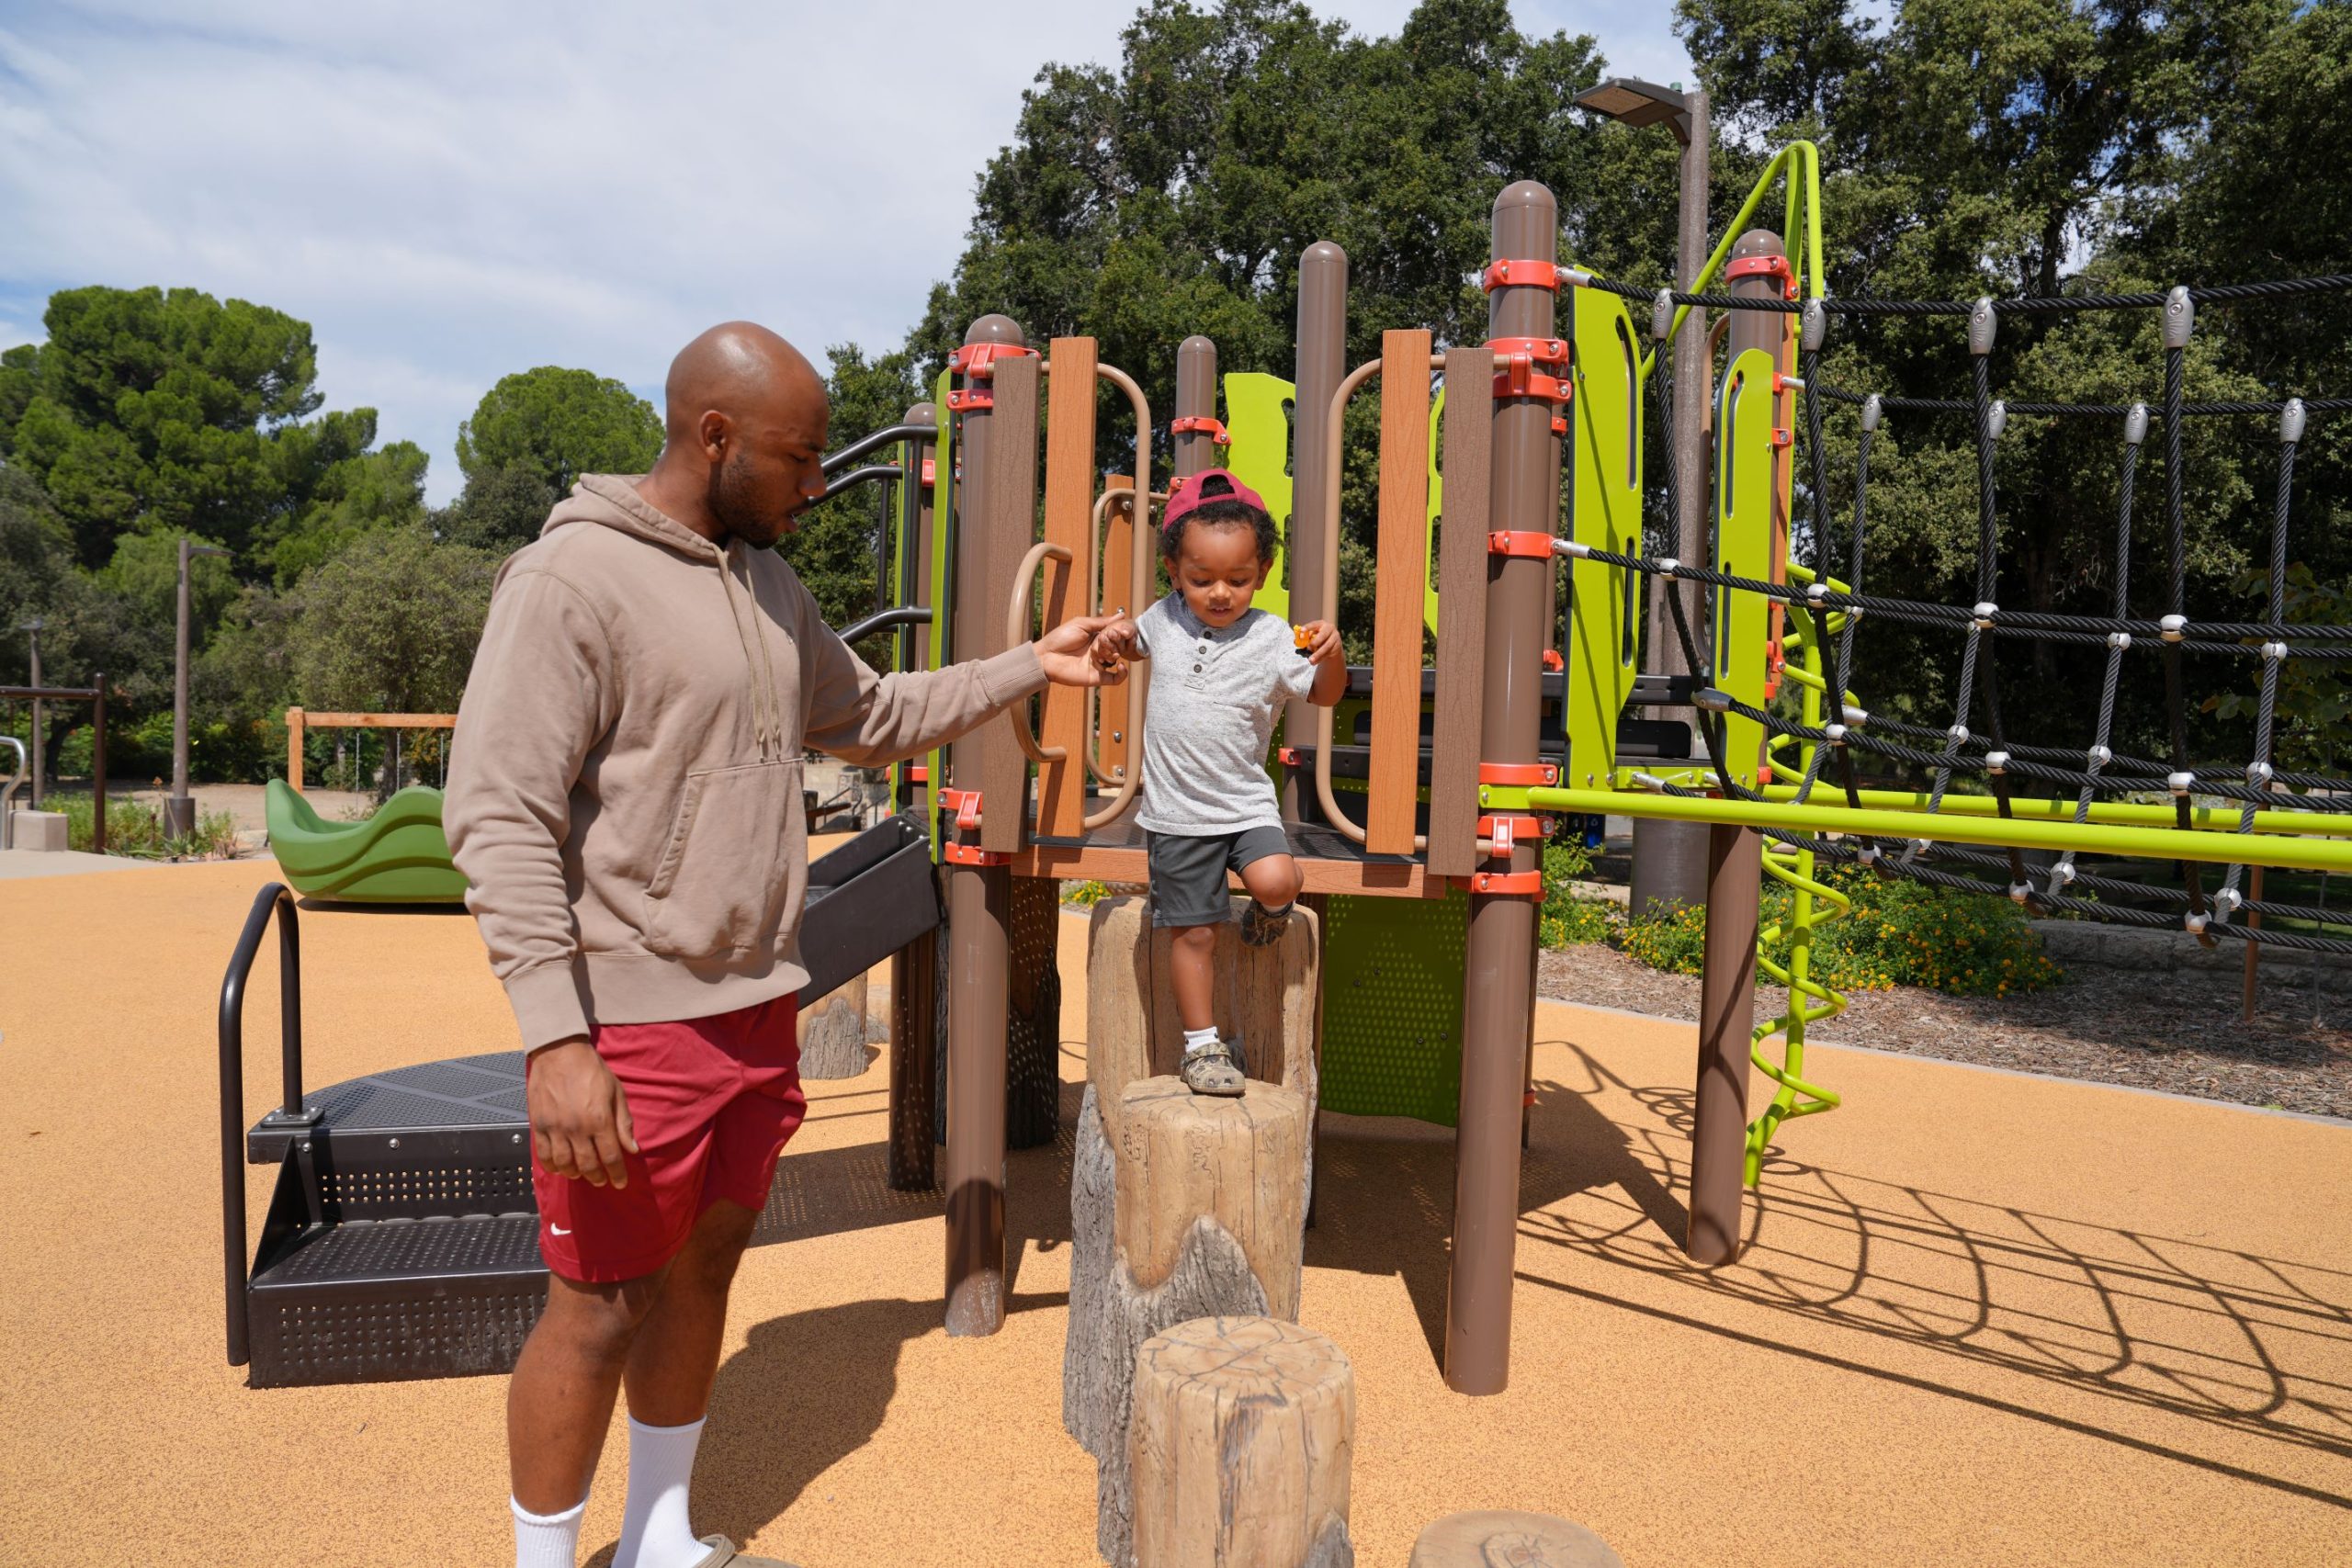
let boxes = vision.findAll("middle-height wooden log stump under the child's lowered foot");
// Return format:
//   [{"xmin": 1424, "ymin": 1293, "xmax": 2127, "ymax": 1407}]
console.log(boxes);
[{"xmin": 1063, "ymin": 1077, "xmax": 1307, "ymax": 1563}]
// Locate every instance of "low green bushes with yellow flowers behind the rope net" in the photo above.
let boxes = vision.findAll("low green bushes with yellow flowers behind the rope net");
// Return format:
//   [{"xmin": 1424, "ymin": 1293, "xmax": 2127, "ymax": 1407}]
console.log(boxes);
[{"xmin": 1621, "ymin": 867, "xmax": 2065, "ymax": 997}]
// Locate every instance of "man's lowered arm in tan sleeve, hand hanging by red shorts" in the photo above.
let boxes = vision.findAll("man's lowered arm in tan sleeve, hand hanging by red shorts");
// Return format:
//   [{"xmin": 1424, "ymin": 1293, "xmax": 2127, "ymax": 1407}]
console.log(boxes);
[{"xmin": 442, "ymin": 571, "xmax": 638, "ymax": 1187}]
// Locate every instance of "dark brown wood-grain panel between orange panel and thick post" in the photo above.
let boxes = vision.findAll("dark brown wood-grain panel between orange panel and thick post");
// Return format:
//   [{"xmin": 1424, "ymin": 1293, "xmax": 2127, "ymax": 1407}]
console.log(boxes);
[{"xmin": 1420, "ymin": 348, "xmax": 1494, "ymax": 877}]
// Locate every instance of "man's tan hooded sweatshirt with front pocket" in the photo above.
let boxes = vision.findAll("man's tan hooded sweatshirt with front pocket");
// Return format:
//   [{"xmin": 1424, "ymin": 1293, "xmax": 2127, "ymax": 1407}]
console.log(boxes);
[{"xmin": 445, "ymin": 475, "xmax": 1045, "ymax": 1048}]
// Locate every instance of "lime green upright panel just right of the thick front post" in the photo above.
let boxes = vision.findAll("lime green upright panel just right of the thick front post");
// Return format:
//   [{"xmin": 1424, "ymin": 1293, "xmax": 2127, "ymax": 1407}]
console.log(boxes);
[{"xmin": 1562, "ymin": 289, "xmax": 1642, "ymax": 785}]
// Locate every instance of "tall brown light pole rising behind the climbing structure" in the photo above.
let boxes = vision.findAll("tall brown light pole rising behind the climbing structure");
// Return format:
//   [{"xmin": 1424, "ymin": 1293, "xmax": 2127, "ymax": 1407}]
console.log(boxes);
[{"xmin": 1576, "ymin": 75, "xmax": 1713, "ymax": 915}]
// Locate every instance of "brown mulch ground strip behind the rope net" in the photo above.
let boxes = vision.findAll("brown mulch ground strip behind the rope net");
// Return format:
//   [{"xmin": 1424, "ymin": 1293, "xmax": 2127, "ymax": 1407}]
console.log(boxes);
[{"xmin": 1541, "ymin": 945, "xmax": 2352, "ymax": 1117}]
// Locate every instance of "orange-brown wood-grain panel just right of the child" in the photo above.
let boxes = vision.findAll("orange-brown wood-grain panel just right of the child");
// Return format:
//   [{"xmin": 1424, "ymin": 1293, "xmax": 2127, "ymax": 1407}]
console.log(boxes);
[{"xmin": 1364, "ymin": 329, "xmax": 1430, "ymax": 856}]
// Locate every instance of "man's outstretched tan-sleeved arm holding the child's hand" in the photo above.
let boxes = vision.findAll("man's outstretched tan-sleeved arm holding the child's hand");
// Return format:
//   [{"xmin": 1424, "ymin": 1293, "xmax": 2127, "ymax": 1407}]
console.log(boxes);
[{"xmin": 795, "ymin": 583, "xmax": 1117, "ymax": 766}]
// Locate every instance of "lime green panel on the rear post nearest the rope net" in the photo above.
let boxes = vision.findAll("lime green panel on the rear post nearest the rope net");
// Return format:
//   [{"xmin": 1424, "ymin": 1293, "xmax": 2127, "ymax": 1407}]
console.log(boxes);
[{"xmin": 1708, "ymin": 348, "xmax": 1773, "ymax": 785}]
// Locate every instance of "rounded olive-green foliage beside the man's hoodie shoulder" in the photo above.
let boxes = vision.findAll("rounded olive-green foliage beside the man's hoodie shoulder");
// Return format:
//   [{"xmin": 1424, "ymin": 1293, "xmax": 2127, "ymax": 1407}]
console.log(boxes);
[{"xmin": 285, "ymin": 526, "xmax": 496, "ymax": 712}]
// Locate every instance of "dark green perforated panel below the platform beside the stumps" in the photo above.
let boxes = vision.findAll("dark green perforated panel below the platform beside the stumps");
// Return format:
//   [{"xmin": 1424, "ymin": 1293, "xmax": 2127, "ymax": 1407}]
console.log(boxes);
[{"xmin": 1322, "ymin": 888, "xmax": 1470, "ymax": 1126}]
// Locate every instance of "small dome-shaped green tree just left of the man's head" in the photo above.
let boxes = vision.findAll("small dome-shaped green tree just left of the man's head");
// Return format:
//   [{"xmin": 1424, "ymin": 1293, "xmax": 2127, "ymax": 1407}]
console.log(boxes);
[{"xmin": 457, "ymin": 365, "xmax": 661, "ymax": 496}]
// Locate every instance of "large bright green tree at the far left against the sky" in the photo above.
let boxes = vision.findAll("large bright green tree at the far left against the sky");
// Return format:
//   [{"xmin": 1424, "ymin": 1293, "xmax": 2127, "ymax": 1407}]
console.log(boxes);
[{"xmin": 0, "ymin": 287, "xmax": 395, "ymax": 567}]
